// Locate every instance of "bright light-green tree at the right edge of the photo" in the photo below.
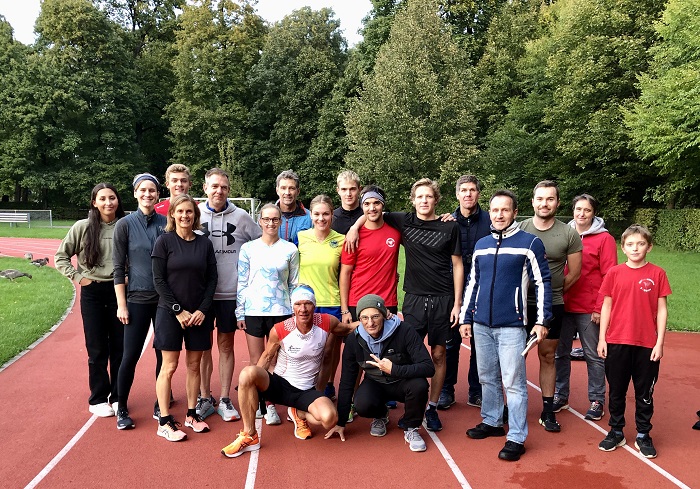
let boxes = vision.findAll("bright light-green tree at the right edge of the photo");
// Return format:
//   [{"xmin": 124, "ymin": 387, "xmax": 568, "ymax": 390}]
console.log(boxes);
[{"xmin": 624, "ymin": 0, "xmax": 700, "ymax": 207}]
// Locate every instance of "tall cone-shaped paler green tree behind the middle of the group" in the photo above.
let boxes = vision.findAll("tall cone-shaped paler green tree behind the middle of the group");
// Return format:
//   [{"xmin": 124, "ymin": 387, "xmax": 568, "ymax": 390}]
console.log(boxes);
[{"xmin": 346, "ymin": 0, "xmax": 475, "ymax": 208}]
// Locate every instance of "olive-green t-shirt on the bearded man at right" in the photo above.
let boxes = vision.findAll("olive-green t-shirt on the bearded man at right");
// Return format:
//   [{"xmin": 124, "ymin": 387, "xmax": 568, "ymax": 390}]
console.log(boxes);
[{"xmin": 520, "ymin": 218, "xmax": 583, "ymax": 306}]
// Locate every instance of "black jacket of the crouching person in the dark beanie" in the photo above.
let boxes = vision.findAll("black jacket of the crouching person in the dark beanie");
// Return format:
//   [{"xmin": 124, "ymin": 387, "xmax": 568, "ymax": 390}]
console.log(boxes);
[{"xmin": 338, "ymin": 323, "xmax": 435, "ymax": 426}]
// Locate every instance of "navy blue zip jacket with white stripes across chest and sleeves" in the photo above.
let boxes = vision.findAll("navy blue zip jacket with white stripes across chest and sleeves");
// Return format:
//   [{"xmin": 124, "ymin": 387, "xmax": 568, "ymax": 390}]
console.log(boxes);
[{"xmin": 460, "ymin": 222, "xmax": 552, "ymax": 328}]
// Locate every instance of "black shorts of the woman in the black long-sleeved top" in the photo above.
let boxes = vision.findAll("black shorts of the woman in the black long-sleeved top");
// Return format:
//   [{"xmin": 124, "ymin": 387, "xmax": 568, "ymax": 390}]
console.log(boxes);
[{"xmin": 153, "ymin": 307, "xmax": 214, "ymax": 351}]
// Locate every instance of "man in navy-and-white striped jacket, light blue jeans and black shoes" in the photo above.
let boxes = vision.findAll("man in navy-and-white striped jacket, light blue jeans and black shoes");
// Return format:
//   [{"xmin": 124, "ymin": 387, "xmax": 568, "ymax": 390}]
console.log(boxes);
[{"xmin": 460, "ymin": 190, "xmax": 552, "ymax": 461}]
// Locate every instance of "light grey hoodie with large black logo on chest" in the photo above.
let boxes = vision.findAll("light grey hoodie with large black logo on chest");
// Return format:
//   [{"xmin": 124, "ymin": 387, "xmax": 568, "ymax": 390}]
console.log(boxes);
[{"xmin": 198, "ymin": 202, "xmax": 262, "ymax": 301}]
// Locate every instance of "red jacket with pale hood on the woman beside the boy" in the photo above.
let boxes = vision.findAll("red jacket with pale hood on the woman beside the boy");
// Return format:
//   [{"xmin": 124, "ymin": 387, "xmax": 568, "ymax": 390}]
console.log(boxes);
[{"xmin": 564, "ymin": 216, "xmax": 617, "ymax": 314}]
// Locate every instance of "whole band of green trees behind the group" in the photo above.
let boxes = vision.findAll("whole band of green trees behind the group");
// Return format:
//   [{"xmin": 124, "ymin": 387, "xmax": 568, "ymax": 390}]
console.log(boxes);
[{"xmin": 0, "ymin": 0, "xmax": 700, "ymax": 221}]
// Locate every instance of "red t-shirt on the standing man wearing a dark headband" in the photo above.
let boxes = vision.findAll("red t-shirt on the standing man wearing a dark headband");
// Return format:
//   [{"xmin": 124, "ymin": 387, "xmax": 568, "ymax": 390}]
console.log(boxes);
[{"xmin": 340, "ymin": 224, "xmax": 401, "ymax": 306}]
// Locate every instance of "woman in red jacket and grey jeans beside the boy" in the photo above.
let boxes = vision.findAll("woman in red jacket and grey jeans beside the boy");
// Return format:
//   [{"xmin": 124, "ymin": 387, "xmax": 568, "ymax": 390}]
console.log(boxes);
[{"xmin": 554, "ymin": 194, "xmax": 617, "ymax": 421}]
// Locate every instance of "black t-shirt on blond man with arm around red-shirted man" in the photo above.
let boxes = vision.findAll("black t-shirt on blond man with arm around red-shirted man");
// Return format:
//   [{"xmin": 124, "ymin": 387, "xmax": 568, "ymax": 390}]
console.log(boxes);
[{"xmin": 384, "ymin": 212, "xmax": 462, "ymax": 296}]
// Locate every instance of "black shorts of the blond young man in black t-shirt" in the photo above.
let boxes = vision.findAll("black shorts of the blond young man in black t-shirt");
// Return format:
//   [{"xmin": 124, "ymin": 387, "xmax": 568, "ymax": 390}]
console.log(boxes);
[{"xmin": 401, "ymin": 293, "xmax": 454, "ymax": 346}]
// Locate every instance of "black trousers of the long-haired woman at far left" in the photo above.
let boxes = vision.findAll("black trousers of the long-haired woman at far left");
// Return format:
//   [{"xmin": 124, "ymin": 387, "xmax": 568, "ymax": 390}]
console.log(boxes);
[{"xmin": 80, "ymin": 282, "xmax": 124, "ymax": 405}]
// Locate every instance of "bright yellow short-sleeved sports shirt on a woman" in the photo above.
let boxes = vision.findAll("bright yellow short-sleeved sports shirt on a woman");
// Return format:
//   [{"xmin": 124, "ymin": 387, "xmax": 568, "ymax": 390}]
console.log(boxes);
[{"xmin": 297, "ymin": 228, "xmax": 345, "ymax": 307}]
